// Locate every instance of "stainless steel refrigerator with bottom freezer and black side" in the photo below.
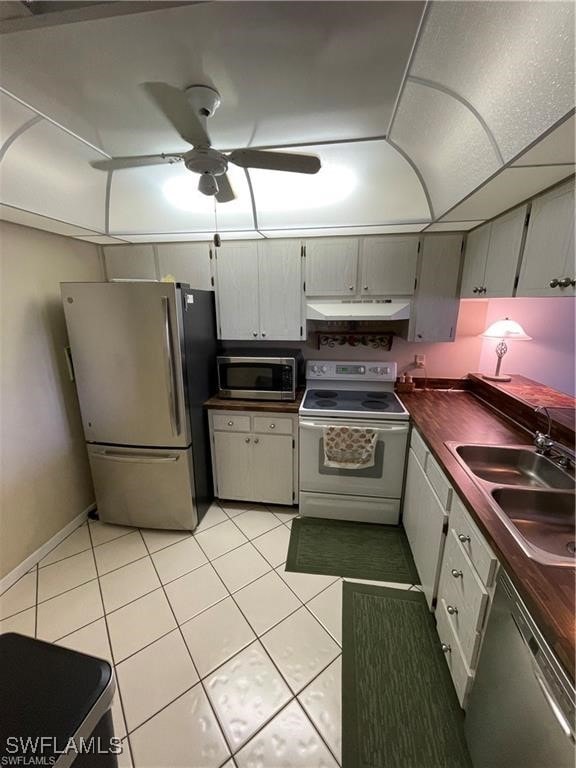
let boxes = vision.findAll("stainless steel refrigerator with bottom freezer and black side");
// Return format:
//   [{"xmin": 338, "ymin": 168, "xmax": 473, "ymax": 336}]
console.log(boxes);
[{"xmin": 61, "ymin": 281, "xmax": 216, "ymax": 530}]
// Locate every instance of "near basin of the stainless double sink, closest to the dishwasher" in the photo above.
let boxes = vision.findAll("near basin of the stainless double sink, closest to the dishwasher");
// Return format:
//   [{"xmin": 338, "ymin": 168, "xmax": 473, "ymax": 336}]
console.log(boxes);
[{"xmin": 492, "ymin": 488, "xmax": 576, "ymax": 562}]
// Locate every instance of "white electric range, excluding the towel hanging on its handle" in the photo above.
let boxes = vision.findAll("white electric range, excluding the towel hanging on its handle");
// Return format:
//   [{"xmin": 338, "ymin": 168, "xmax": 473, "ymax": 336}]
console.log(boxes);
[{"xmin": 299, "ymin": 360, "xmax": 410, "ymax": 525}]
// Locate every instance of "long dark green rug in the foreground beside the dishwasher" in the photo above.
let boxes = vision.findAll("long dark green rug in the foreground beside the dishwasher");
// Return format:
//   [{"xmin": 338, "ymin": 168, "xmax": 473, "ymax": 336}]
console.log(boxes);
[{"xmin": 342, "ymin": 582, "xmax": 472, "ymax": 768}]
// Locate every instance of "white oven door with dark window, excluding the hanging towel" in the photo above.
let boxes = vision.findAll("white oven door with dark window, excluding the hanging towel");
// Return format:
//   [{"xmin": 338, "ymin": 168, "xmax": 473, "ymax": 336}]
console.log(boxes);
[{"xmin": 300, "ymin": 419, "xmax": 409, "ymax": 499}]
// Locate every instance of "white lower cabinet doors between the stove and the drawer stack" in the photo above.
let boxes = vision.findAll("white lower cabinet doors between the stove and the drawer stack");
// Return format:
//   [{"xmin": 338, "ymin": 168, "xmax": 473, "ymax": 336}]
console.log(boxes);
[{"xmin": 402, "ymin": 449, "xmax": 448, "ymax": 609}]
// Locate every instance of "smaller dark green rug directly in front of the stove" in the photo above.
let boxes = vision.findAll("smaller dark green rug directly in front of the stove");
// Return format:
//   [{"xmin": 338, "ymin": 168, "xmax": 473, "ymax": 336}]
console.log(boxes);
[{"xmin": 286, "ymin": 517, "xmax": 420, "ymax": 584}]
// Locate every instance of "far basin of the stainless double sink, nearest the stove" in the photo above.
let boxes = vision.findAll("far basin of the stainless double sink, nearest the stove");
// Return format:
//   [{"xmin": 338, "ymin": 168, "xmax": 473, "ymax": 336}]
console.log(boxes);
[{"xmin": 456, "ymin": 445, "xmax": 575, "ymax": 489}]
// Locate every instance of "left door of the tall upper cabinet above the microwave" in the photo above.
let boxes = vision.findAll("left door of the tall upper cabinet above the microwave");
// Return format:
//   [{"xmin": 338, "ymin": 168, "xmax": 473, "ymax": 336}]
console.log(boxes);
[{"xmin": 215, "ymin": 242, "xmax": 260, "ymax": 339}]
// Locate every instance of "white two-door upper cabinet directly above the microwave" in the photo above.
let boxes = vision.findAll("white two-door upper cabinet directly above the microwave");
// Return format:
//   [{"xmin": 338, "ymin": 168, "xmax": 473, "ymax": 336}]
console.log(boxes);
[{"xmin": 214, "ymin": 240, "xmax": 305, "ymax": 341}]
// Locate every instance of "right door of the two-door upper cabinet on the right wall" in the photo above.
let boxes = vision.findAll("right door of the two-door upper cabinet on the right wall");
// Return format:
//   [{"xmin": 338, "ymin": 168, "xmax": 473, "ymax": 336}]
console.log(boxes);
[{"xmin": 482, "ymin": 205, "xmax": 527, "ymax": 298}]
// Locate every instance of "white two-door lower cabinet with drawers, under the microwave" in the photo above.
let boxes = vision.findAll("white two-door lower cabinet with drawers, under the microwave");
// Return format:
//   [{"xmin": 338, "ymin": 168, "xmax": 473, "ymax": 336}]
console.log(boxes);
[{"xmin": 209, "ymin": 411, "xmax": 298, "ymax": 505}]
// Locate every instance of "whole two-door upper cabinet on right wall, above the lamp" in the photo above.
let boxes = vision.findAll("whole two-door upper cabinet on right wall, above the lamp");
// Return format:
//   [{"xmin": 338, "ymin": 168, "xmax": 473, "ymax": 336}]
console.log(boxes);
[{"xmin": 460, "ymin": 205, "xmax": 527, "ymax": 299}]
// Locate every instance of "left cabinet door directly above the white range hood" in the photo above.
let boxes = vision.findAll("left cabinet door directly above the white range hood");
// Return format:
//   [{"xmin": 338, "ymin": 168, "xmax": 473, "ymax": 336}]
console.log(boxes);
[{"xmin": 305, "ymin": 237, "xmax": 358, "ymax": 296}]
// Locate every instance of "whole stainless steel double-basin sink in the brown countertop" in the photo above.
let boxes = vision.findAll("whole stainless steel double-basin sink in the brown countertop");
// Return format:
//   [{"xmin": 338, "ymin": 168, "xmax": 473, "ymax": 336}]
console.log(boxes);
[{"xmin": 446, "ymin": 442, "xmax": 576, "ymax": 567}]
